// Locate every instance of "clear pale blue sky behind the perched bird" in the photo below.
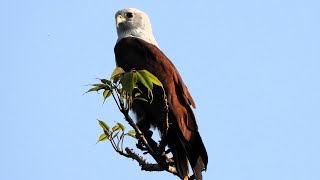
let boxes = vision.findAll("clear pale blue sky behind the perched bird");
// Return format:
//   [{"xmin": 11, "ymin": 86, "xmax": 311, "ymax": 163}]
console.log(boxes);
[{"xmin": 0, "ymin": 0, "xmax": 320, "ymax": 180}]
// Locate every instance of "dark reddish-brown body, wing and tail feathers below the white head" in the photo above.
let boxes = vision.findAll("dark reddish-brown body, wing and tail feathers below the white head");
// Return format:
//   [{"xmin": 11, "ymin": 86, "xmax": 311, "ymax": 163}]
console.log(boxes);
[{"xmin": 114, "ymin": 37, "xmax": 208, "ymax": 180}]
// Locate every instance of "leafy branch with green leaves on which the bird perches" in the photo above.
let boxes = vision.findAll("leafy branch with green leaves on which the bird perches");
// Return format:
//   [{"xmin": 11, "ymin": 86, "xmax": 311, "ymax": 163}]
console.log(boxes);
[{"xmin": 88, "ymin": 67, "xmax": 179, "ymax": 179}]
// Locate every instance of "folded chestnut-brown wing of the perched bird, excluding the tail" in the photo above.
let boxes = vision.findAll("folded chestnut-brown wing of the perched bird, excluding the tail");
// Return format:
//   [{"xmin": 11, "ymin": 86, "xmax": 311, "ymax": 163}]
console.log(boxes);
[{"xmin": 115, "ymin": 37, "xmax": 198, "ymax": 134}]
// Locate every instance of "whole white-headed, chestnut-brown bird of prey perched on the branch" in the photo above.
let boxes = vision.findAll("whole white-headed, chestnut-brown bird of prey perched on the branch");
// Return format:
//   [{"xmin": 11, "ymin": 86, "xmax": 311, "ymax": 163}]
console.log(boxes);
[{"xmin": 114, "ymin": 8, "xmax": 208, "ymax": 180}]
